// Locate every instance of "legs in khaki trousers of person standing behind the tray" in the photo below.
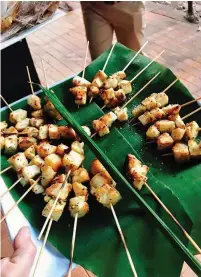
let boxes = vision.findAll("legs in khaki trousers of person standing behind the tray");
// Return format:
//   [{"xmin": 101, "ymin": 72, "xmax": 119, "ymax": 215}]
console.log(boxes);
[{"xmin": 81, "ymin": 1, "xmax": 146, "ymax": 60}]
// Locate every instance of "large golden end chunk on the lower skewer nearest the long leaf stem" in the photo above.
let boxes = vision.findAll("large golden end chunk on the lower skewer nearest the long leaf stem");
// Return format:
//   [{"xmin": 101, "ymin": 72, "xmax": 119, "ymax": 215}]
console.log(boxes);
[{"xmin": 95, "ymin": 184, "xmax": 121, "ymax": 208}]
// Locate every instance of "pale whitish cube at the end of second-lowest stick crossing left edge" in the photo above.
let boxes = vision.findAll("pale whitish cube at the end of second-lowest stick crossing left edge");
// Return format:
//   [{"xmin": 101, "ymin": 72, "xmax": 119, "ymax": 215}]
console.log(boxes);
[{"xmin": 19, "ymin": 165, "xmax": 40, "ymax": 187}]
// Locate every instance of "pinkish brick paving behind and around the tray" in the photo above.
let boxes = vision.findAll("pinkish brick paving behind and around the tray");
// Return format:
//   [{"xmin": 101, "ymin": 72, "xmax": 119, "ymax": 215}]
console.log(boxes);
[{"xmin": 1, "ymin": 2, "xmax": 201, "ymax": 277}]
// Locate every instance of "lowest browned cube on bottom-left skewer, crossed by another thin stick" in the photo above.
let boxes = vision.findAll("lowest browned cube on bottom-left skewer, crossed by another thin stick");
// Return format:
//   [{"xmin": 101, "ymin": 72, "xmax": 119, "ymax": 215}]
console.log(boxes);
[{"xmin": 42, "ymin": 199, "xmax": 66, "ymax": 221}]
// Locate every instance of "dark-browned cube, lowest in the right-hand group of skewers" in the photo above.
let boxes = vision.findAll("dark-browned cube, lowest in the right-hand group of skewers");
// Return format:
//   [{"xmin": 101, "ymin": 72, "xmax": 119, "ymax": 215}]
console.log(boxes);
[{"xmin": 172, "ymin": 142, "xmax": 190, "ymax": 163}]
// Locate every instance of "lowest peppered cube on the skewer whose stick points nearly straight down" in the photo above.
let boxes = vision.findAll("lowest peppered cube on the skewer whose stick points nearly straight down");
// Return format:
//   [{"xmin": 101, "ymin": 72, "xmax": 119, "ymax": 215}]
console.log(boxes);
[{"xmin": 69, "ymin": 196, "xmax": 89, "ymax": 218}]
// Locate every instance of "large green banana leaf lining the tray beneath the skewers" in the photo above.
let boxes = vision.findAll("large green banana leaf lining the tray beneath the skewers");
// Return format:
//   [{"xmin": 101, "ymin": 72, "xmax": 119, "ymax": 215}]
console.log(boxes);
[{"xmin": 1, "ymin": 44, "xmax": 201, "ymax": 277}]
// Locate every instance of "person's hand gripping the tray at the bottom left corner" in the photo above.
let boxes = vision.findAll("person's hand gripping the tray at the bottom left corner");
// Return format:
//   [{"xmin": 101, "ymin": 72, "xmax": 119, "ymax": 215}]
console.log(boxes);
[{"xmin": 1, "ymin": 227, "xmax": 36, "ymax": 277}]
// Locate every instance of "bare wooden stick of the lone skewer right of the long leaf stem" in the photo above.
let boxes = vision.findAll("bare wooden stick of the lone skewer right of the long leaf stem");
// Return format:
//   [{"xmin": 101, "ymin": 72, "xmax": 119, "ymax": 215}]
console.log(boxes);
[{"xmin": 145, "ymin": 183, "xmax": 201, "ymax": 254}]
